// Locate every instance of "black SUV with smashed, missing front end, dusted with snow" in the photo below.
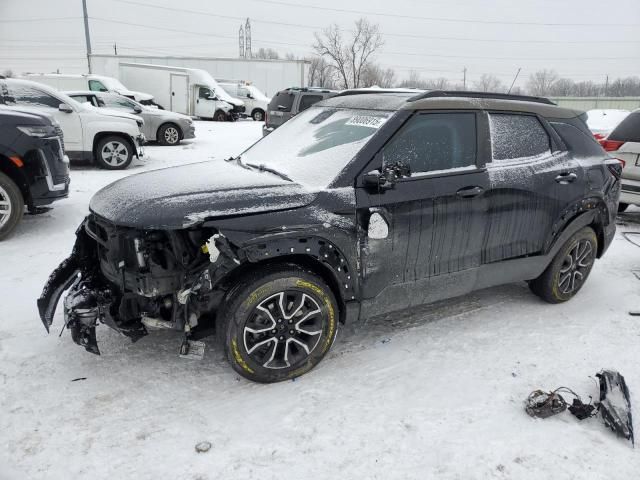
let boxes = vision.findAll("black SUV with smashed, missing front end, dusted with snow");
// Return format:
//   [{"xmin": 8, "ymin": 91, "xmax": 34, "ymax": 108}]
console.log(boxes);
[{"xmin": 38, "ymin": 90, "xmax": 621, "ymax": 382}]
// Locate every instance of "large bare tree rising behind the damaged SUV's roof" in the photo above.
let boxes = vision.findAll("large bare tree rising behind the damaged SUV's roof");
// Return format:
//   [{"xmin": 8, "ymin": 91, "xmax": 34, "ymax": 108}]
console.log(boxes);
[{"xmin": 313, "ymin": 18, "xmax": 384, "ymax": 88}]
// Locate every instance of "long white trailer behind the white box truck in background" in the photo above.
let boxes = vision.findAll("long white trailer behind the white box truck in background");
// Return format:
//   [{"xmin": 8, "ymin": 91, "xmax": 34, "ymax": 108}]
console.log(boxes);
[{"xmin": 91, "ymin": 55, "xmax": 310, "ymax": 97}]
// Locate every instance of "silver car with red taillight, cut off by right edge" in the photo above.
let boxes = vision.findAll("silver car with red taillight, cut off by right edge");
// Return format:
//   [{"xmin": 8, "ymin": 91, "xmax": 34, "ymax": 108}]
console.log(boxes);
[{"xmin": 600, "ymin": 109, "xmax": 640, "ymax": 212}]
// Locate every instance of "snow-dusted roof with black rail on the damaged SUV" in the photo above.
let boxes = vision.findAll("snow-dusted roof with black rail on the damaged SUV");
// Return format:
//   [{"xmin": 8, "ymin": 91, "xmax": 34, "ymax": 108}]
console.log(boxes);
[{"xmin": 315, "ymin": 89, "xmax": 584, "ymax": 118}]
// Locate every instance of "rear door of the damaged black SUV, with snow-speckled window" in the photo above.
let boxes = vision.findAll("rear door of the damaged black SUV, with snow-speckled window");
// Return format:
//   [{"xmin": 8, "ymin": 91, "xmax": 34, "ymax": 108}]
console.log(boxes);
[{"xmin": 483, "ymin": 112, "xmax": 584, "ymax": 263}]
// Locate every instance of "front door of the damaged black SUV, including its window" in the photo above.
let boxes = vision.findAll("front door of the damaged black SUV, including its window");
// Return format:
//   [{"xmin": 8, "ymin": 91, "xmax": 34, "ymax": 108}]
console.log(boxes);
[{"xmin": 357, "ymin": 111, "xmax": 488, "ymax": 310}]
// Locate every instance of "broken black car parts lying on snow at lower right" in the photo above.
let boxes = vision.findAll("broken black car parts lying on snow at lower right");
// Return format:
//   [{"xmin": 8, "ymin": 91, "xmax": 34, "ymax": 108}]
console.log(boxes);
[{"xmin": 525, "ymin": 370, "xmax": 635, "ymax": 445}]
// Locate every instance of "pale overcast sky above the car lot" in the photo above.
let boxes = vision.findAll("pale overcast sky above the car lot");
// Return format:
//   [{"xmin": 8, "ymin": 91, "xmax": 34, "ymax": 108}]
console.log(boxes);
[{"xmin": 0, "ymin": 0, "xmax": 640, "ymax": 84}]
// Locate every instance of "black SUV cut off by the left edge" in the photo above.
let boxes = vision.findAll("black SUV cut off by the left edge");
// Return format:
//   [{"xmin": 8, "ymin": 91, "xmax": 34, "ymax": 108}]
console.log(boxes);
[{"xmin": 0, "ymin": 107, "xmax": 69, "ymax": 240}]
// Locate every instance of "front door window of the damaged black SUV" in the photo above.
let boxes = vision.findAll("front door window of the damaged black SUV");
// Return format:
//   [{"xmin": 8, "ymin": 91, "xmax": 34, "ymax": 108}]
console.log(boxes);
[{"xmin": 382, "ymin": 112, "xmax": 477, "ymax": 174}]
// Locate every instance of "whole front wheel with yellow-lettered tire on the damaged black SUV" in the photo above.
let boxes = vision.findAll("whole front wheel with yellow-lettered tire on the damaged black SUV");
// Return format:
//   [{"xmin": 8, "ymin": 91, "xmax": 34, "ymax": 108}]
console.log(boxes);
[{"xmin": 216, "ymin": 266, "xmax": 338, "ymax": 383}]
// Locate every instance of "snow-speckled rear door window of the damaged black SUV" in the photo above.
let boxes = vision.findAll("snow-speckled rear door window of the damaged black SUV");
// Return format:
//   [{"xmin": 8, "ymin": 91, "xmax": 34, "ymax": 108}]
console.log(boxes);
[{"xmin": 489, "ymin": 113, "xmax": 551, "ymax": 160}]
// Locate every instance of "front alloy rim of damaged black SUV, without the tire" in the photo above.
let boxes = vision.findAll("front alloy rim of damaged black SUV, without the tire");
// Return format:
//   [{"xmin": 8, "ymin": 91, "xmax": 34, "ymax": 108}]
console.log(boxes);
[{"xmin": 243, "ymin": 290, "xmax": 324, "ymax": 369}]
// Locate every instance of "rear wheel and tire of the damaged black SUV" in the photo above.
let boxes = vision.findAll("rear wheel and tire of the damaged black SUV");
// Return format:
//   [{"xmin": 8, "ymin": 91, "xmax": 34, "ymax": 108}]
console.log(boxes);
[{"xmin": 529, "ymin": 227, "xmax": 598, "ymax": 303}]
